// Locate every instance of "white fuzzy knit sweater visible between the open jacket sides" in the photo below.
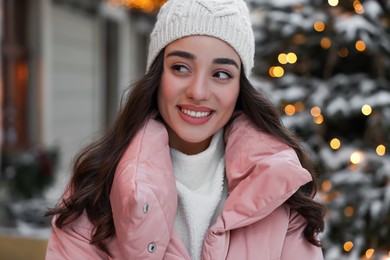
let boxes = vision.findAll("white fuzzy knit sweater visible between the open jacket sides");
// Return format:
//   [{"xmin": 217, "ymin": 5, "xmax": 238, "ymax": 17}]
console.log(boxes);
[{"xmin": 171, "ymin": 130, "xmax": 227, "ymax": 260}]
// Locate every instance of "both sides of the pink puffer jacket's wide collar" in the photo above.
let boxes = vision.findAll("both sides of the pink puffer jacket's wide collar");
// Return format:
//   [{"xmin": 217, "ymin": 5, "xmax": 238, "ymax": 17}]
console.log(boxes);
[{"xmin": 110, "ymin": 114, "xmax": 311, "ymax": 259}]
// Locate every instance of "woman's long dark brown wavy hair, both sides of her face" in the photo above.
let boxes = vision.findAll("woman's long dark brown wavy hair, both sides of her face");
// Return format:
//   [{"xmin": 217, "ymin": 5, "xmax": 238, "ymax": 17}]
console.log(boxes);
[{"xmin": 46, "ymin": 50, "xmax": 324, "ymax": 255}]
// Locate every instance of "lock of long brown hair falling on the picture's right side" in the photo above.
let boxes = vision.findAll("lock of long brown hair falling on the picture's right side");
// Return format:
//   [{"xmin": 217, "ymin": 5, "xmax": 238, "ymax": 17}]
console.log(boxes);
[{"xmin": 236, "ymin": 71, "xmax": 326, "ymax": 246}]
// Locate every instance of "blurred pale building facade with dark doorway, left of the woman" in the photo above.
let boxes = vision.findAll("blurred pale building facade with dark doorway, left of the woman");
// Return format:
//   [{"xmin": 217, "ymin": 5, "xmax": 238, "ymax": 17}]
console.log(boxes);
[{"xmin": 0, "ymin": 0, "xmax": 157, "ymax": 200}]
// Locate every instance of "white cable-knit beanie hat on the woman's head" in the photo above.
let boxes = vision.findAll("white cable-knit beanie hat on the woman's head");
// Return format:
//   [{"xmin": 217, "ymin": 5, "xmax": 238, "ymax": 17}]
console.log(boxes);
[{"xmin": 147, "ymin": 0, "xmax": 255, "ymax": 76}]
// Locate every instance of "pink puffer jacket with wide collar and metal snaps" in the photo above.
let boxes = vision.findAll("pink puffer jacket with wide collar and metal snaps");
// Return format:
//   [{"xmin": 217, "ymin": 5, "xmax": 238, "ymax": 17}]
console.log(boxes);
[{"xmin": 46, "ymin": 115, "xmax": 323, "ymax": 260}]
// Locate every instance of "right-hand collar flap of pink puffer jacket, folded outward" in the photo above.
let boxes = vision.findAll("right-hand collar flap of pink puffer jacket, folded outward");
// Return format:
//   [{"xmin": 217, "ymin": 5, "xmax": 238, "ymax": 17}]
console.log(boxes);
[{"xmin": 202, "ymin": 114, "xmax": 312, "ymax": 259}]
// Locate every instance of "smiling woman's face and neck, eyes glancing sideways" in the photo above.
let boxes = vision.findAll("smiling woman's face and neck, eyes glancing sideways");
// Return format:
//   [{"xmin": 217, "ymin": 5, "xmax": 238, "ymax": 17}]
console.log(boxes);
[{"xmin": 158, "ymin": 36, "xmax": 241, "ymax": 154}]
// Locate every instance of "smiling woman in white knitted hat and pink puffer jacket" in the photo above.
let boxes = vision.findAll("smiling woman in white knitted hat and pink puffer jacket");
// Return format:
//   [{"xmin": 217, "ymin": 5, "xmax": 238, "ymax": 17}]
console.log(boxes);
[{"xmin": 46, "ymin": 0, "xmax": 324, "ymax": 260}]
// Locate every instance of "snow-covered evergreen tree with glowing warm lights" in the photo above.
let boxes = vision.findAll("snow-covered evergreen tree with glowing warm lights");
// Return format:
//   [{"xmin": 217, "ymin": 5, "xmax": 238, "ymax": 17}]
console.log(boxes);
[{"xmin": 247, "ymin": 0, "xmax": 390, "ymax": 259}]
